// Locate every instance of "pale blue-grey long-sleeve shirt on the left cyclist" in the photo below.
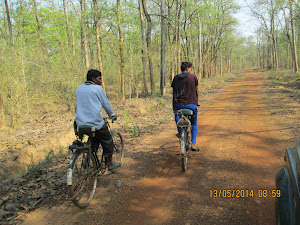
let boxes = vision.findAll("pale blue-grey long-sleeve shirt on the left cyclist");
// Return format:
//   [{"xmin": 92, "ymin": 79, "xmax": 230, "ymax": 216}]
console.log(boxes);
[{"xmin": 75, "ymin": 84, "xmax": 115, "ymax": 130}]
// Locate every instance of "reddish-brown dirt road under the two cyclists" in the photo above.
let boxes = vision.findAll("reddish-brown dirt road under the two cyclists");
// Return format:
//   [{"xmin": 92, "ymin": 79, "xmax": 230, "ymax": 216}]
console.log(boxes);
[{"xmin": 24, "ymin": 72, "xmax": 299, "ymax": 225}]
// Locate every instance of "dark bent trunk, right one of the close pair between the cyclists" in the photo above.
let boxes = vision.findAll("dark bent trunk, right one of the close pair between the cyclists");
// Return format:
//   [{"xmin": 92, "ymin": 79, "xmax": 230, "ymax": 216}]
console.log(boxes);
[{"xmin": 142, "ymin": 0, "xmax": 155, "ymax": 95}]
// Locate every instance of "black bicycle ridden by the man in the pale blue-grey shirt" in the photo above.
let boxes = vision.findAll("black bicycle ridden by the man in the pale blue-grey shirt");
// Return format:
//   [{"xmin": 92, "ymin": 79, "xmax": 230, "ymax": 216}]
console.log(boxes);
[{"xmin": 67, "ymin": 117, "xmax": 124, "ymax": 209}]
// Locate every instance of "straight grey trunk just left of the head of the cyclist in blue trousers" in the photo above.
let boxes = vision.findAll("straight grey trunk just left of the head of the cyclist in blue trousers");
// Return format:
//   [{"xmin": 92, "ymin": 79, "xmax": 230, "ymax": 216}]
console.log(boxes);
[{"xmin": 160, "ymin": 0, "xmax": 166, "ymax": 96}]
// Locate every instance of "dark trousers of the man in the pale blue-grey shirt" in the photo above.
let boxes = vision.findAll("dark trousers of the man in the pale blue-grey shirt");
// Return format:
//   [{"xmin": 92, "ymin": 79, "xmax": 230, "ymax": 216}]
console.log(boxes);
[{"xmin": 92, "ymin": 124, "xmax": 114, "ymax": 155}]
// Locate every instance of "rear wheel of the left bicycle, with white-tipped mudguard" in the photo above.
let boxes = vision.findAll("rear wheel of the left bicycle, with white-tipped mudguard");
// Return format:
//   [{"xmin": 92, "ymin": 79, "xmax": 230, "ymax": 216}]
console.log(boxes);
[{"xmin": 67, "ymin": 149, "xmax": 97, "ymax": 209}]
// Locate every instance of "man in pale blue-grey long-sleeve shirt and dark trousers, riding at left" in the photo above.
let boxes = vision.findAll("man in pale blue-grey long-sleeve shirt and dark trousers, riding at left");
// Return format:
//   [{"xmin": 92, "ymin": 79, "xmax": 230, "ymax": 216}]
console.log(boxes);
[{"xmin": 75, "ymin": 69, "xmax": 120, "ymax": 172}]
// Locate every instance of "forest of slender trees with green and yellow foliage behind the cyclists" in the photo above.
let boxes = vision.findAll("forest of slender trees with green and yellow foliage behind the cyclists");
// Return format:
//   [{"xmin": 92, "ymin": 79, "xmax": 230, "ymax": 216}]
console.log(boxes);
[{"xmin": 0, "ymin": 0, "xmax": 300, "ymax": 128}]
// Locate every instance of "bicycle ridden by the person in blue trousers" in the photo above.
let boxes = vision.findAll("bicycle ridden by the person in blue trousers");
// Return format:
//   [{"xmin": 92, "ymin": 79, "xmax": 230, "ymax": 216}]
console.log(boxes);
[{"xmin": 177, "ymin": 109, "xmax": 193, "ymax": 172}]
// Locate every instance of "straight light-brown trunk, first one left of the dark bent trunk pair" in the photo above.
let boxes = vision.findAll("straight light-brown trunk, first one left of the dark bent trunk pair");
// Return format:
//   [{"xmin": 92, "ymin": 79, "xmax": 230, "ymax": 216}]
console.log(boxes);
[{"xmin": 117, "ymin": 0, "xmax": 125, "ymax": 100}]
